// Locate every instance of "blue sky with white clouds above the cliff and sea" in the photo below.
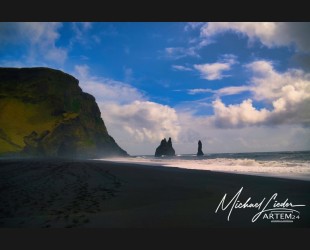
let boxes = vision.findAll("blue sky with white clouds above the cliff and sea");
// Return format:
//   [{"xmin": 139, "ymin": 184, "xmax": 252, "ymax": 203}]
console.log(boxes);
[{"xmin": 0, "ymin": 22, "xmax": 310, "ymax": 155}]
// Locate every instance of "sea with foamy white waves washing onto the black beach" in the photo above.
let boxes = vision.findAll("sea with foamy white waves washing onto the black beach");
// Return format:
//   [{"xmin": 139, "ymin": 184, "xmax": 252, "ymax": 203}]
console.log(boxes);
[{"xmin": 102, "ymin": 151, "xmax": 310, "ymax": 181}]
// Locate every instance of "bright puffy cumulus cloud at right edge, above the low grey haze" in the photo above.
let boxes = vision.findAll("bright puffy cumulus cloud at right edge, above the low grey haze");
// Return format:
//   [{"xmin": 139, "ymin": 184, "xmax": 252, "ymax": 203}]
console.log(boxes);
[{"xmin": 210, "ymin": 61, "xmax": 310, "ymax": 127}]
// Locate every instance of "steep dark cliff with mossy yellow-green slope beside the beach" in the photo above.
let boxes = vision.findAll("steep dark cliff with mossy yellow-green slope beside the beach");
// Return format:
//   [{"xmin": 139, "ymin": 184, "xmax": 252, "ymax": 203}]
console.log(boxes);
[{"xmin": 0, "ymin": 68, "xmax": 127, "ymax": 157}]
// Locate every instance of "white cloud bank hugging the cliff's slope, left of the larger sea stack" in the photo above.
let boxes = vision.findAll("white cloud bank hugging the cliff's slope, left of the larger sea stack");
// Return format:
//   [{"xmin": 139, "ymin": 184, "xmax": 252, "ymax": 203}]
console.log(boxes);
[{"xmin": 74, "ymin": 65, "xmax": 180, "ymax": 154}]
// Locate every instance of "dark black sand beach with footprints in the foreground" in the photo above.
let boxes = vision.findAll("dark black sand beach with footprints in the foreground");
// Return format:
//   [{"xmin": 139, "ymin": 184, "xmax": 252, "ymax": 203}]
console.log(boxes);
[{"xmin": 0, "ymin": 159, "xmax": 310, "ymax": 228}]
